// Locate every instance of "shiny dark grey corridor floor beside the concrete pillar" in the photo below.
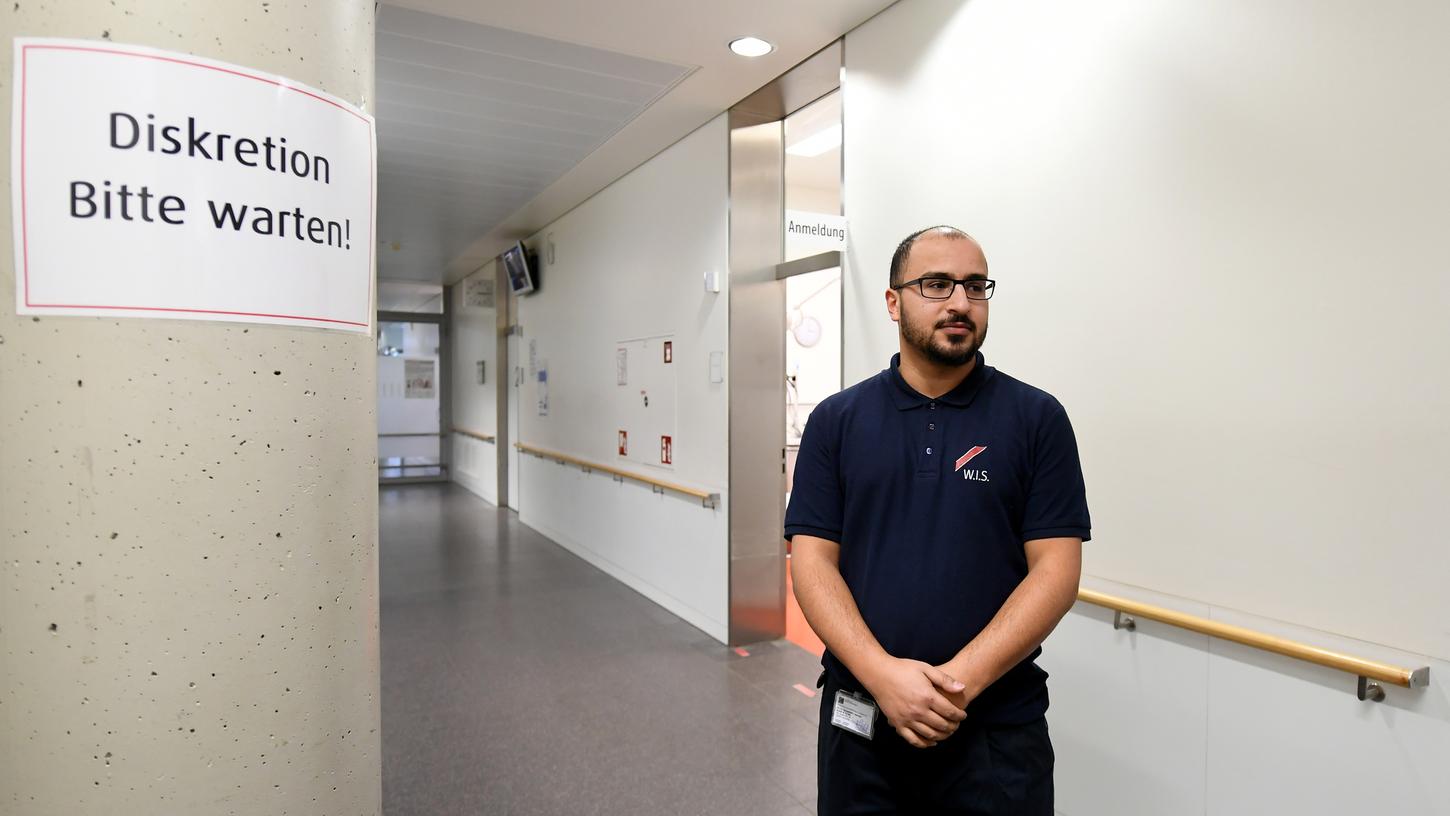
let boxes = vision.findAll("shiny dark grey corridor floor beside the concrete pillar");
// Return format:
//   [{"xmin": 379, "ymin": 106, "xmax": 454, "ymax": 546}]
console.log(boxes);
[{"xmin": 380, "ymin": 484, "xmax": 819, "ymax": 816}]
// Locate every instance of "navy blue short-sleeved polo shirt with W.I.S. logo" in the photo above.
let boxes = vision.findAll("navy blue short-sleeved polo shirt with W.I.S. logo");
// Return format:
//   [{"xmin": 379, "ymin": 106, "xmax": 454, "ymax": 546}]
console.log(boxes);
[{"xmin": 786, "ymin": 352, "xmax": 1090, "ymax": 723}]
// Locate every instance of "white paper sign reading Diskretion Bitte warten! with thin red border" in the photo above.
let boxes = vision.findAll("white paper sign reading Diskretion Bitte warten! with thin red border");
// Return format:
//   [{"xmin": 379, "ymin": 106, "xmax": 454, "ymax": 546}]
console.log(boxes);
[{"xmin": 10, "ymin": 38, "xmax": 377, "ymax": 333}]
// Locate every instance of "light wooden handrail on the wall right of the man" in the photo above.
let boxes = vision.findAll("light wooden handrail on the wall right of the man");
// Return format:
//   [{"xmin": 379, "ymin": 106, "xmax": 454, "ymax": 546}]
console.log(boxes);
[{"xmin": 1077, "ymin": 590, "xmax": 1430, "ymax": 699}]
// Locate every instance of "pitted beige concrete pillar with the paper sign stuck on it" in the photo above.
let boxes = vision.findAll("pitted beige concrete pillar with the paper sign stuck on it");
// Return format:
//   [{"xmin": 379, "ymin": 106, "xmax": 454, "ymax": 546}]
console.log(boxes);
[{"xmin": 0, "ymin": 0, "xmax": 381, "ymax": 816}]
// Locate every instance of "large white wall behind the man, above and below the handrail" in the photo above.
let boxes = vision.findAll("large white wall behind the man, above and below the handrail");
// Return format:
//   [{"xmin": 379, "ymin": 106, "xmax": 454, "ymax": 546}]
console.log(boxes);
[{"xmin": 844, "ymin": 0, "xmax": 1450, "ymax": 816}]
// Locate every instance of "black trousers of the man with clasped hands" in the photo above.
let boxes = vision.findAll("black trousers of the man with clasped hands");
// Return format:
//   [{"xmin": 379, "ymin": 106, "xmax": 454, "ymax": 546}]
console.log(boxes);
[{"xmin": 816, "ymin": 678, "xmax": 1054, "ymax": 816}]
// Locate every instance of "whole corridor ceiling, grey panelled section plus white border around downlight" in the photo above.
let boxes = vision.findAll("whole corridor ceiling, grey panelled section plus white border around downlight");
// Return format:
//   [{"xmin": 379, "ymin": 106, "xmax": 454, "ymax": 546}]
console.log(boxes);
[{"xmin": 377, "ymin": 0, "xmax": 895, "ymax": 283}]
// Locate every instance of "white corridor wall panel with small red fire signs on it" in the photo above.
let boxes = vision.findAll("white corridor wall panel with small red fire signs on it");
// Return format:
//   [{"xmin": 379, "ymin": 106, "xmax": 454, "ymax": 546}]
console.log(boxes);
[{"xmin": 615, "ymin": 335, "xmax": 679, "ymax": 470}]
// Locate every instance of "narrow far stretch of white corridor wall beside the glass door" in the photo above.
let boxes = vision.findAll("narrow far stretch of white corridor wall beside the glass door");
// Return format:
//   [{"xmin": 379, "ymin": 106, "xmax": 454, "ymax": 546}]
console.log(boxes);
[{"xmin": 448, "ymin": 261, "xmax": 508, "ymax": 504}]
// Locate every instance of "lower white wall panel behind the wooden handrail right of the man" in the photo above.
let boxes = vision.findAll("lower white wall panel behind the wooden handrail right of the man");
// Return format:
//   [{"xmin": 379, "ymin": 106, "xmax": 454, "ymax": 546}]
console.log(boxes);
[{"xmin": 1040, "ymin": 576, "xmax": 1450, "ymax": 816}]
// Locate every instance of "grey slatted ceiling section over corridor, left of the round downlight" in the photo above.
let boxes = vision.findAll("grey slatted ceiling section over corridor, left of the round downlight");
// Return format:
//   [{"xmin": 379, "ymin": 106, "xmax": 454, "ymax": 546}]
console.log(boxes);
[{"xmin": 377, "ymin": 6, "xmax": 692, "ymax": 281}]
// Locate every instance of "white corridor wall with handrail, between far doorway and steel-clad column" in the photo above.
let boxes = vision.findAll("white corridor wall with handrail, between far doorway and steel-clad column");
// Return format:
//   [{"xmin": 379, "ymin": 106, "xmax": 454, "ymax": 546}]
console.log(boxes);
[{"xmin": 518, "ymin": 116, "xmax": 729, "ymax": 641}]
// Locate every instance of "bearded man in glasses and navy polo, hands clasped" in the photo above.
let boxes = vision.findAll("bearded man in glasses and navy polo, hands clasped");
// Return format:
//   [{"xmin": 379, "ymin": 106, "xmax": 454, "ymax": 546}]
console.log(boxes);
[{"xmin": 786, "ymin": 226, "xmax": 1090, "ymax": 816}]
